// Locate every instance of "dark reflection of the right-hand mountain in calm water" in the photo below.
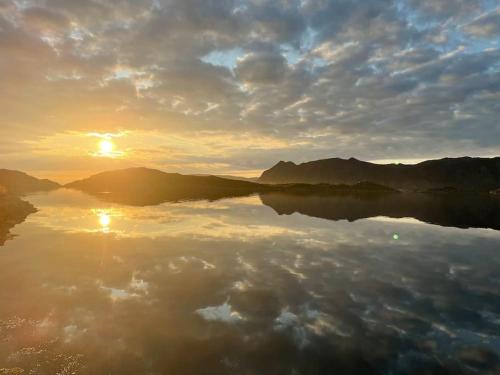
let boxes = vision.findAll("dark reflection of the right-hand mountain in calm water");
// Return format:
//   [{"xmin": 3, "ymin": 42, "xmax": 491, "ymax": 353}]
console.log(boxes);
[{"xmin": 260, "ymin": 193, "xmax": 500, "ymax": 230}]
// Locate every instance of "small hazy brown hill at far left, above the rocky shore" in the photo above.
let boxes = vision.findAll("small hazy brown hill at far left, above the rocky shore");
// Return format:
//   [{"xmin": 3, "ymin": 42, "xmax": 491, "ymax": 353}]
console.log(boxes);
[{"xmin": 0, "ymin": 169, "xmax": 60, "ymax": 195}]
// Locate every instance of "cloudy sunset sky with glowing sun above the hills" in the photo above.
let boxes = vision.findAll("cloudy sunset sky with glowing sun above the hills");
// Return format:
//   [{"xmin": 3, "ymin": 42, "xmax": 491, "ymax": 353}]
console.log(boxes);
[{"xmin": 0, "ymin": 0, "xmax": 500, "ymax": 182}]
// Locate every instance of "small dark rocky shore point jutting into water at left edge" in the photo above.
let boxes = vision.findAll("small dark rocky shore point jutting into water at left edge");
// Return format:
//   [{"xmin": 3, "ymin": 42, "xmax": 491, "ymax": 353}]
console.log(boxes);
[{"xmin": 0, "ymin": 192, "xmax": 36, "ymax": 246}]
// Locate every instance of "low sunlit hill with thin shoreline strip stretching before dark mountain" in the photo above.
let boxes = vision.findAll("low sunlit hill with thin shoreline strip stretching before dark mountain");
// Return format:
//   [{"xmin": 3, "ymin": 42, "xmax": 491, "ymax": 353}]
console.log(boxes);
[{"xmin": 65, "ymin": 168, "xmax": 395, "ymax": 206}]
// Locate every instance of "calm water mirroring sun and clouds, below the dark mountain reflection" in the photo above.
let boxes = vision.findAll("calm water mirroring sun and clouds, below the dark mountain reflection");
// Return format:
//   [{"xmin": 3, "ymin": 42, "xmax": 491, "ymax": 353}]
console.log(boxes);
[{"xmin": 0, "ymin": 189, "xmax": 500, "ymax": 374}]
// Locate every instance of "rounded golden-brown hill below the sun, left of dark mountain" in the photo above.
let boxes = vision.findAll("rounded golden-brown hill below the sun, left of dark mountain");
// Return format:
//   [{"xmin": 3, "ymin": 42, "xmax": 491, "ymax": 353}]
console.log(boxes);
[{"xmin": 65, "ymin": 168, "xmax": 270, "ymax": 205}]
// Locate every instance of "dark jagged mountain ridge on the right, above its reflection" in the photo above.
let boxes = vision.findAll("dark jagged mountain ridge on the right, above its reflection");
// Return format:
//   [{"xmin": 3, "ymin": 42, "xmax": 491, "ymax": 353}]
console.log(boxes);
[{"xmin": 259, "ymin": 157, "xmax": 500, "ymax": 191}]
